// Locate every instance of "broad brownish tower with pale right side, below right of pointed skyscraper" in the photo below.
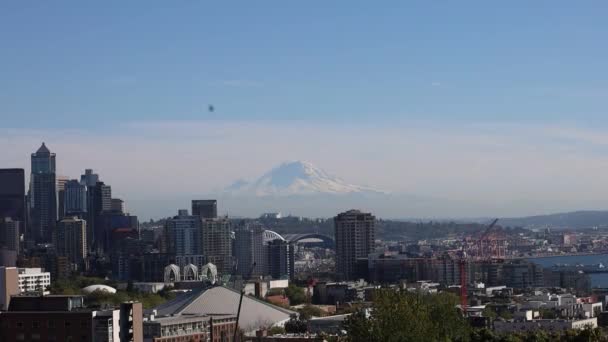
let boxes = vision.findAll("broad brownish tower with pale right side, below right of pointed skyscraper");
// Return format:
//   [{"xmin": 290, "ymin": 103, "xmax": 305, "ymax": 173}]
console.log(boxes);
[{"xmin": 55, "ymin": 217, "xmax": 88, "ymax": 269}]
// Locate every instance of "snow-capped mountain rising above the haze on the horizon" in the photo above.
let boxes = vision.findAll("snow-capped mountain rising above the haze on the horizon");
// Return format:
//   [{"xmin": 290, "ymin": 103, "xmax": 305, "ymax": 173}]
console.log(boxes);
[{"xmin": 225, "ymin": 161, "xmax": 382, "ymax": 196}]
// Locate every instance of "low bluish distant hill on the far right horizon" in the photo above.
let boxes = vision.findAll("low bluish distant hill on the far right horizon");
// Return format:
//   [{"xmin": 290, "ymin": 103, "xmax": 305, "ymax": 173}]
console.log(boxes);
[{"xmin": 499, "ymin": 210, "xmax": 608, "ymax": 229}]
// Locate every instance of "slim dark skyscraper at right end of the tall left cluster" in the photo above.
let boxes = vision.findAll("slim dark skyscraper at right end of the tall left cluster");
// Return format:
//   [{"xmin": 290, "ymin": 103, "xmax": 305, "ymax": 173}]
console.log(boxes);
[{"xmin": 87, "ymin": 181, "xmax": 112, "ymax": 249}]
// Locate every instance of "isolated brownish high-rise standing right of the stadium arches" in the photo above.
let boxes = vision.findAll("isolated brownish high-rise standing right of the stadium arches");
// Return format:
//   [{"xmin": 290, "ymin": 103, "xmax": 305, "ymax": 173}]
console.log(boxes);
[{"xmin": 334, "ymin": 210, "xmax": 376, "ymax": 280}]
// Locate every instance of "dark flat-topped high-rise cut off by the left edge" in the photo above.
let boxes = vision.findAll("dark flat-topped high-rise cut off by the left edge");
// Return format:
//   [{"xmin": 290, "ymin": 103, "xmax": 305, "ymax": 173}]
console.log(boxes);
[{"xmin": 0, "ymin": 169, "xmax": 27, "ymax": 224}]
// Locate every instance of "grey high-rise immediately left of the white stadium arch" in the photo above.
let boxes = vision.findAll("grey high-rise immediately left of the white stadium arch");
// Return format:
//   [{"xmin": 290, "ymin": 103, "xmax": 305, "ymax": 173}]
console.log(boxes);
[{"xmin": 234, "ymin": 225, "xmax": 268, "ymax": 277}]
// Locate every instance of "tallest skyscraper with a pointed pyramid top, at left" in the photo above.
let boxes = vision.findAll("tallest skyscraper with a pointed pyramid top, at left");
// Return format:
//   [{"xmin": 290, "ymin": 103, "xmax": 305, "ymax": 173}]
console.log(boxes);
[{"xmin": 28, "ymin": 143, "xmax": 57, "ymax": 242}]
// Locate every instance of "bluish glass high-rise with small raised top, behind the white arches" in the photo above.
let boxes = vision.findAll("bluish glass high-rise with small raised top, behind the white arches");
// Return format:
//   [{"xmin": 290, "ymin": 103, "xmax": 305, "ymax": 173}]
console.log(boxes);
[{"xmin": 164, "ymin": 210, "xmax": 202, "ymax": 255}]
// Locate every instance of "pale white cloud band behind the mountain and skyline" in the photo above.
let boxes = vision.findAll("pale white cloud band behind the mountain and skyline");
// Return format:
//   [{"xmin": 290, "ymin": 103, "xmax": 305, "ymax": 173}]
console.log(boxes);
[{"xmin": 0, "ymin": 121, "xmax": 608, "ymax": 216}]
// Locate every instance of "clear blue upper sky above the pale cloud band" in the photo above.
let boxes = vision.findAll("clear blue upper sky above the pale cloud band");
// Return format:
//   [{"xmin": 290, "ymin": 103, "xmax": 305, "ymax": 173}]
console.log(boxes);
[{"xmin": 0, "ymin": 1, "xmax": 608, "ymax": 128}]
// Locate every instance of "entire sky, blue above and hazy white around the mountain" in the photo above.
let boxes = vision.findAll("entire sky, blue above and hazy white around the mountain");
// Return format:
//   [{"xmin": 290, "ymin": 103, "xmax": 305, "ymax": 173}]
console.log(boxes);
[{"xmin": 0, "ymin": 1, "xmax": 608, "ymax": 216}]
